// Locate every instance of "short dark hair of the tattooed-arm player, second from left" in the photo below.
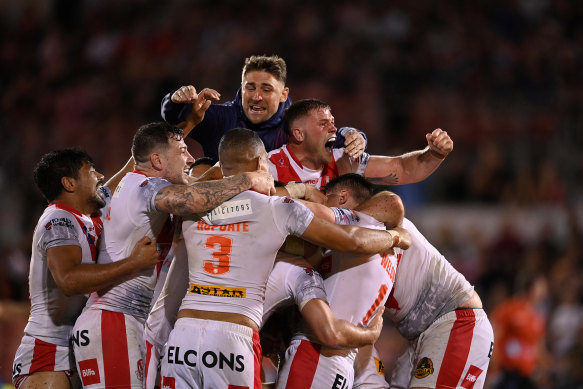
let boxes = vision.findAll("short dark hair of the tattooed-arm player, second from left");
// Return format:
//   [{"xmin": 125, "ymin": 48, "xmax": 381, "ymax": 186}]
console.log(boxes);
[{"xmin": 132, "ymin": 122, "xmax": 184, "ymax": 163}]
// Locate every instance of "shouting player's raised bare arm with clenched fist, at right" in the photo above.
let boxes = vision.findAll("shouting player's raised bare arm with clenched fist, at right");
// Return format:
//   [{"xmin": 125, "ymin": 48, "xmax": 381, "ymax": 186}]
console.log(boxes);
[{"xmin": 364, "ymin": 128, "xmax": 453, "ymax": 185}]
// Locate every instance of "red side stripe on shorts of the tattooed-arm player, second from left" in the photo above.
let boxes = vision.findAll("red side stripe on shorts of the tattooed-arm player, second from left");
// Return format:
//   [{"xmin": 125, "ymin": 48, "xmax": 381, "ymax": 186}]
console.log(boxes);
[{"xmin": 101, "ymin": 311, "xmax": 131, "ymax": 388}]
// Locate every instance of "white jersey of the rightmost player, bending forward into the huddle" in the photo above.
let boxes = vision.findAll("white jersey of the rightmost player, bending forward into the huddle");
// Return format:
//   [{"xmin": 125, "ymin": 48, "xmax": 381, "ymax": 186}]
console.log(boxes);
[{"xmin": 385, "ymin": 219, "xmax": 474, "ymax": 339}]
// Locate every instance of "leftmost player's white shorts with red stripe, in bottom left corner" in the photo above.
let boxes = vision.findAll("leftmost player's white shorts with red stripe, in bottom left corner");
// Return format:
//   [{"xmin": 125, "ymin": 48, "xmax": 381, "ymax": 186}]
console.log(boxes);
[{"xmin": 12, "ymin": 335, "xmax": 75, "ymax": 387}]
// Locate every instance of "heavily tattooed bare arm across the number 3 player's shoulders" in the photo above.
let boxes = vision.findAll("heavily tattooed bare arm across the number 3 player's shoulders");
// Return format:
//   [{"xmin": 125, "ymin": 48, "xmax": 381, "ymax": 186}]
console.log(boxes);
[{"xmin": 154, "ymin": 171, "xmax": 275, "ymax": 217}]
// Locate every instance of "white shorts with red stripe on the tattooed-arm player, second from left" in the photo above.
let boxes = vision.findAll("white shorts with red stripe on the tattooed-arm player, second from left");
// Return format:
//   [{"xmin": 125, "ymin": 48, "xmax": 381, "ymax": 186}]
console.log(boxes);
[{"xmin": 72, "ymin": 309, "xmax": 145, "ymax": 389}]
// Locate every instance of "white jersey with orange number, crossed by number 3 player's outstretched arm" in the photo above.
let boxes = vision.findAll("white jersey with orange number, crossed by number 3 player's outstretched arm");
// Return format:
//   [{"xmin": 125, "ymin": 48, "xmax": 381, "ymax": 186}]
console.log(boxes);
[{"xmin": 320, "ymin": 208, "xmax": 403, "ymax": 326}]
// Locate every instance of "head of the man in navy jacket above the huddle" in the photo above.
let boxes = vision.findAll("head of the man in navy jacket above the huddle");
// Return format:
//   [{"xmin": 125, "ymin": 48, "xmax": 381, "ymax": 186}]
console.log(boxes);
[{"xmin": 241, "ymin": 55, "xmax": 289, "ymax": 124}]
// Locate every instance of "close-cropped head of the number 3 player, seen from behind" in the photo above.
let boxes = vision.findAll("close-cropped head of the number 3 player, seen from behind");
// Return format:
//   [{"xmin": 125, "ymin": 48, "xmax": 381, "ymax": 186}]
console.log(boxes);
[{"xmin": 219, "ymin": 128, "xmax": 267, "ymax": 177}]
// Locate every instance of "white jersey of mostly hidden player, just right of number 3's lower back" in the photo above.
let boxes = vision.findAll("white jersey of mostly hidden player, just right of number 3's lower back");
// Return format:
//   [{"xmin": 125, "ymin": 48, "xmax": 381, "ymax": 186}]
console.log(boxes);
[{"xmin": 262, "ymin": 258, "xmax": 328, "ymax": 325}]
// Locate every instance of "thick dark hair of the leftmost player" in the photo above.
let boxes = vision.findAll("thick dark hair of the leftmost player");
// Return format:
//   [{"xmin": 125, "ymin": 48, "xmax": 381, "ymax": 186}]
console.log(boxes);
[{"xmin": 33, "ymin": 147, "xmax": 93, "ymax": 203}]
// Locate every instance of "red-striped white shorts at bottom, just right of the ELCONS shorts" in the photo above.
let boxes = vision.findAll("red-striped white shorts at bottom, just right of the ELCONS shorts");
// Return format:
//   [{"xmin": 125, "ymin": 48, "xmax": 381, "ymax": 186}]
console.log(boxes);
[{"xmin": 277, "ymin": 338, "xmax": 356, "ymax": 389}]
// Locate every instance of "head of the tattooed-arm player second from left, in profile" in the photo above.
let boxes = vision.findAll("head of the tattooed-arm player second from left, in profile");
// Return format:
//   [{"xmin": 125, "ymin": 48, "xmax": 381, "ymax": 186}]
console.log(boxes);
[{"xmin": 132, "ymin": 122, "xmax": 194, "ymax": 184}]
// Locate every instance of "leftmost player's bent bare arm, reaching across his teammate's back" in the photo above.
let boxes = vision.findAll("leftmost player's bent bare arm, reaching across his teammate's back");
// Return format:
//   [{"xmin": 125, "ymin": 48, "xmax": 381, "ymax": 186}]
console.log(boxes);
[{"xmin": 47, "ymin": 237, "xmax": 160, "ymax": 296}]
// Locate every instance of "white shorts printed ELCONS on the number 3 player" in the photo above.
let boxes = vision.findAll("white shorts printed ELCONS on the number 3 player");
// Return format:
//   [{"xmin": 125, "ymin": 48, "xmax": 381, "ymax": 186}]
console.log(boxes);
[{"xmin": 161, "ymin": 318, "xmax": 261, "ymax": 389}]
